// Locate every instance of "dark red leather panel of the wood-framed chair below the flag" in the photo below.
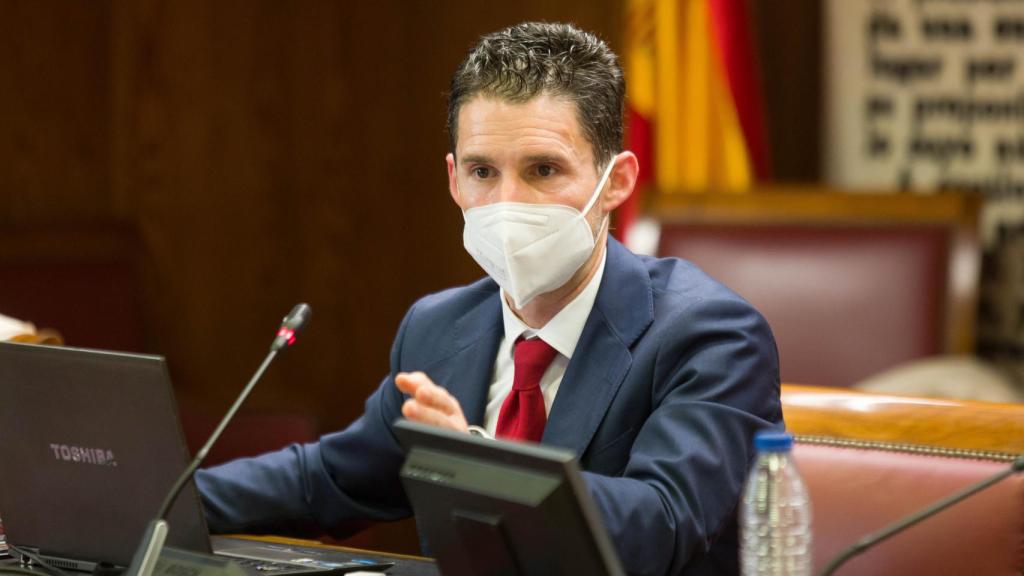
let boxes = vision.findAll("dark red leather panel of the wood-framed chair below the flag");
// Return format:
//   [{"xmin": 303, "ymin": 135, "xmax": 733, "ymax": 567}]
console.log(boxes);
[{"xmin": 660, "ymin": 224, "xmax": 946, "ymax": 385}]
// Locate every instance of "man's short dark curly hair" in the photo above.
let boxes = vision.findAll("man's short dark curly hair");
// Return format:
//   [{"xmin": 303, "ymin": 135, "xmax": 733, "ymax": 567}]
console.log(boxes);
[{"xmin": 447, "ymin": 22, "xmax": 626, "ymax": 167}]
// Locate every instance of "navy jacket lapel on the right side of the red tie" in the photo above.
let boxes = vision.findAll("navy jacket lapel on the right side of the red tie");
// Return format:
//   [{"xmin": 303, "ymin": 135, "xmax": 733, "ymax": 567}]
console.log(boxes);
[{"xmin": 542, "ymin": 239, "xmax": 653, "ymax": 457}]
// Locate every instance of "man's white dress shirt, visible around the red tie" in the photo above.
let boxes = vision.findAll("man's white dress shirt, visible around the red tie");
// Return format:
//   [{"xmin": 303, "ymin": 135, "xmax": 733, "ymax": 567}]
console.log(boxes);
[{"xmin": 483, "ymin": 251, "xmax": 607, "ymax": 436}]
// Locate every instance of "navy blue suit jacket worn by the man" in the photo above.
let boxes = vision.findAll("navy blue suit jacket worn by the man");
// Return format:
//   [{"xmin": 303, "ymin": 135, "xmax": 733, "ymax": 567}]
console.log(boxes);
[{"xmin": 197, "ymin": 235, "xmax": 782, "ymax": 575}]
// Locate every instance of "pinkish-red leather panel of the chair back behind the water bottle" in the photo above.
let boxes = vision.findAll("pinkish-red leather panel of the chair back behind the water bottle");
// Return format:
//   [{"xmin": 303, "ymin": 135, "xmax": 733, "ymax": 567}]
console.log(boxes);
[{"xmin": 795, "ymin": 443, "xmax": 1024, "ymax": 576}]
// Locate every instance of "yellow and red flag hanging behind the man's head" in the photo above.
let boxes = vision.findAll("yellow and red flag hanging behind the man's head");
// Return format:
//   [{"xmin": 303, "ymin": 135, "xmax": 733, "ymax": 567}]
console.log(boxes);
[{"xmin": 616, "ymin": 0, "xmax": 770, "ymax": 237}]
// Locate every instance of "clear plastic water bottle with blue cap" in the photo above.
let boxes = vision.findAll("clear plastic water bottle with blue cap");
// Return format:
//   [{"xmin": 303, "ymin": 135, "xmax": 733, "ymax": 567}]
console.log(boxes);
[{"xmin": 739, "ymin": 431, "xmax": 812, "ymax": 576}]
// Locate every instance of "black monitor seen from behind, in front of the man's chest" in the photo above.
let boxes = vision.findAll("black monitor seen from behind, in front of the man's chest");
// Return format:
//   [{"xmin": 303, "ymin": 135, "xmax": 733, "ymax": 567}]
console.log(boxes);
[{"xmin": 394, "ymin": 420, "xmax": 625, "ymax": 576}]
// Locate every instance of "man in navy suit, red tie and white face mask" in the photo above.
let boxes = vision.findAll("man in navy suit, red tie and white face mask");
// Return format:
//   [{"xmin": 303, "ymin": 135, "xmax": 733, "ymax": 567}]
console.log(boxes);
[{"xmin": 197, "ymin": 24, "xmax": 781, "ymax": 575}]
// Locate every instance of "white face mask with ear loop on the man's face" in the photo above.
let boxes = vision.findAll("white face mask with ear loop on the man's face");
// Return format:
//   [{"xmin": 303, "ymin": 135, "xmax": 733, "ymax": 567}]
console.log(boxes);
[{"xmin": 456, "ymin": 160, "xmax": 614, "ymax": 308}]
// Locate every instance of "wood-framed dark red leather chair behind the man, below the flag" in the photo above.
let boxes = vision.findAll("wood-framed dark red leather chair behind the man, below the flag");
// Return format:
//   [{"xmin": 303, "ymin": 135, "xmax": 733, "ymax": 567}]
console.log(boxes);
[{"xmin": 648, "ymin": 189, "xmax": 981, "ymax": 386}]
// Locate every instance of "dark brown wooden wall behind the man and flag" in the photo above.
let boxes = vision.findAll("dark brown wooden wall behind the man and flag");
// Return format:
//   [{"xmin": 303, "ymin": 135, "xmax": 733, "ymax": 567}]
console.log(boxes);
[{"xmin": 0, "ymin": 0, "xmax": 821, "ymax": 430}]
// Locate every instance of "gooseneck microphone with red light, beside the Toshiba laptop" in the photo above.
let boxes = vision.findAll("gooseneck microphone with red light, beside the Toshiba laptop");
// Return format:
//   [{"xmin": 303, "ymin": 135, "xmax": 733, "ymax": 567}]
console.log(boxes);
[{"xmin": 125, "ymin": 303, "xmax": 312, "ymax": 576}]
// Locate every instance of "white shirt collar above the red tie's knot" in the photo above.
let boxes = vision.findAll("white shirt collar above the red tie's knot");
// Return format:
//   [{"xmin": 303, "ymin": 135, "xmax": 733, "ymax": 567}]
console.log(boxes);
[{"xmin": 499, "ymin": 249, "xmax": 608, "ymax": 358}]
